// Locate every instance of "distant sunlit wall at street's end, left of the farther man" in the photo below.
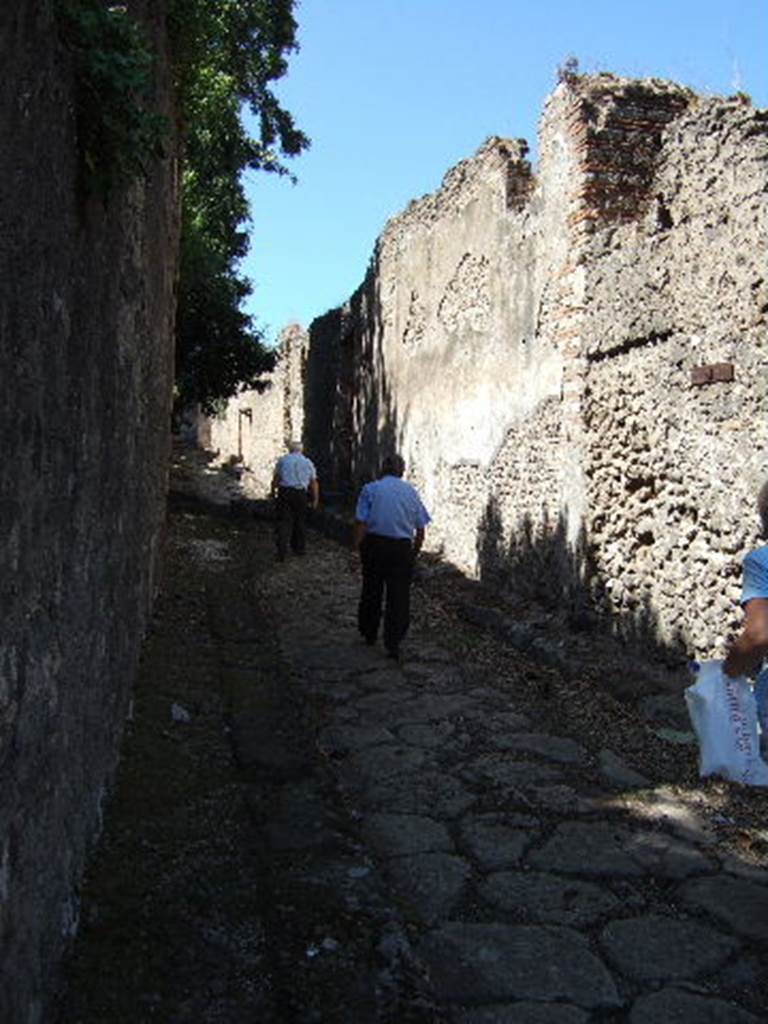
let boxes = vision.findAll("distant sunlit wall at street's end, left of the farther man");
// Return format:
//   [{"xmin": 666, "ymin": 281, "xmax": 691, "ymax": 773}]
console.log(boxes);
[{"xmin": 204, "ymin": 326, "xmax": 307, "ymax": 498}]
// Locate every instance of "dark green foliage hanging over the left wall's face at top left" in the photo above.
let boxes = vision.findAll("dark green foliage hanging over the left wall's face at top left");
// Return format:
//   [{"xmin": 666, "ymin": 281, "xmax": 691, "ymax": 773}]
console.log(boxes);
[{"xmin": 56, "ymin": 0, "xmax": 169, "ymax": 196}]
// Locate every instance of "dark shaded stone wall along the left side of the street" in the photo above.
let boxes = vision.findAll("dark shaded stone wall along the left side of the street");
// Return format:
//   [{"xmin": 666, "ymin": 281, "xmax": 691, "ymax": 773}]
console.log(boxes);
[{"xmin": 0, "ymin": 0, "xmax": 177, "ymax": 1024}]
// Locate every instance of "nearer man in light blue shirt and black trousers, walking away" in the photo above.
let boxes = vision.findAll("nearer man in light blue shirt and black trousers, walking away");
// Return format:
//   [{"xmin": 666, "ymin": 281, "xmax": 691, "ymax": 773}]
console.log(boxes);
[{"xmin": 352, "ymin": 455, "xmax": 430, "ymax": 658}]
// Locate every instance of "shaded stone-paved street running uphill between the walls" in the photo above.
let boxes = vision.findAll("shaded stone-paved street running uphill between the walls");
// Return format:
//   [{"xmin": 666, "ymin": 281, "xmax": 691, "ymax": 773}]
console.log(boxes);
[{"xmin": 57, "ymin": 452, "xmax": 768, "ymax": 1024}]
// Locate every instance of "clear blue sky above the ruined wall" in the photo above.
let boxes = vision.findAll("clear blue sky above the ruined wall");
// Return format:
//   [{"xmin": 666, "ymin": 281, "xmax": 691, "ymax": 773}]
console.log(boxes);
[{"xmin": 242, "ymin": 0, "xmax": 768, "ymax": 341}]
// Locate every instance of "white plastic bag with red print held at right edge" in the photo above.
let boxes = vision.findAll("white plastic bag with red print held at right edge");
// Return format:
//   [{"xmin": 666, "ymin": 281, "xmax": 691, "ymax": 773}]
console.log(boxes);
[{"xmin": 685, "ymin": 662, "xmax": 768, "ymax": 785}]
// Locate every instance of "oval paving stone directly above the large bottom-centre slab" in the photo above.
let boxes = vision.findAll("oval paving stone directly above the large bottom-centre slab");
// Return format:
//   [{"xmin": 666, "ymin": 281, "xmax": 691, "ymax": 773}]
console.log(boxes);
[{"xmin": 478, "ymin": 871, "xmax": 621, "ymax": 928}]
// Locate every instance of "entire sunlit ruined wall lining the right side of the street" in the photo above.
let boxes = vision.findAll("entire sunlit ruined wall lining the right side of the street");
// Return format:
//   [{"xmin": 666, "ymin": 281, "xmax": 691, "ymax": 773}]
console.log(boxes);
[{"xmin": 207, "ymin": 75, "xmax": 768, "ymax": 653}]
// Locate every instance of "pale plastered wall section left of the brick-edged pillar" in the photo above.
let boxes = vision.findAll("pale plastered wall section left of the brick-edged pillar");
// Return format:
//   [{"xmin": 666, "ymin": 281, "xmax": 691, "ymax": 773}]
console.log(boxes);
[{"xmin": 308, "ymin": 128, "xmax": 570, "ymax": 570}]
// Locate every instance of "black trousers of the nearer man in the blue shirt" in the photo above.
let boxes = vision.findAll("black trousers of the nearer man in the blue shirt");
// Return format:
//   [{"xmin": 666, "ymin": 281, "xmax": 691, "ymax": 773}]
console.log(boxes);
[{"xmin": 357, "ymin": 534, "xmax": 414, "ymax": 651}]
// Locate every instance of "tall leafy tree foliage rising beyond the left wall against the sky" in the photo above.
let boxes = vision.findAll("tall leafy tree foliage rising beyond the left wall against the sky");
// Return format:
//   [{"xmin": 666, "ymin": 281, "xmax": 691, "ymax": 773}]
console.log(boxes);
[{"xmin": 169, "ymin": 0, "xmax": 308, "ymax": 413}]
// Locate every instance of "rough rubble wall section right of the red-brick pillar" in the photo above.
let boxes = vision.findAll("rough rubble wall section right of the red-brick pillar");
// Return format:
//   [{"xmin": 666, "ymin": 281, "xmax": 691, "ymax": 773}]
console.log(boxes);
[{"xmin": 584, "ymin": 83, "xmax": 768, "ymax": 651}]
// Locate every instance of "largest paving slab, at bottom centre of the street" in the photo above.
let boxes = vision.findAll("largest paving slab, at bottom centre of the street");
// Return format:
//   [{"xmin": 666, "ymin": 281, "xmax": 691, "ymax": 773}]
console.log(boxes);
[{"xmin": 417, "ymin": 922, "xmax": 622, "ymax": 1009}]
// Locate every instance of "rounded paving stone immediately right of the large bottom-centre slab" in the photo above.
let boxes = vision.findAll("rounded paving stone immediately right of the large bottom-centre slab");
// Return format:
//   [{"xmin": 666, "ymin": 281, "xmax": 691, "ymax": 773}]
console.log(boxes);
[{"xmin": 600, "ymin": 914, "xmax": 738, "ymax": 981}]
